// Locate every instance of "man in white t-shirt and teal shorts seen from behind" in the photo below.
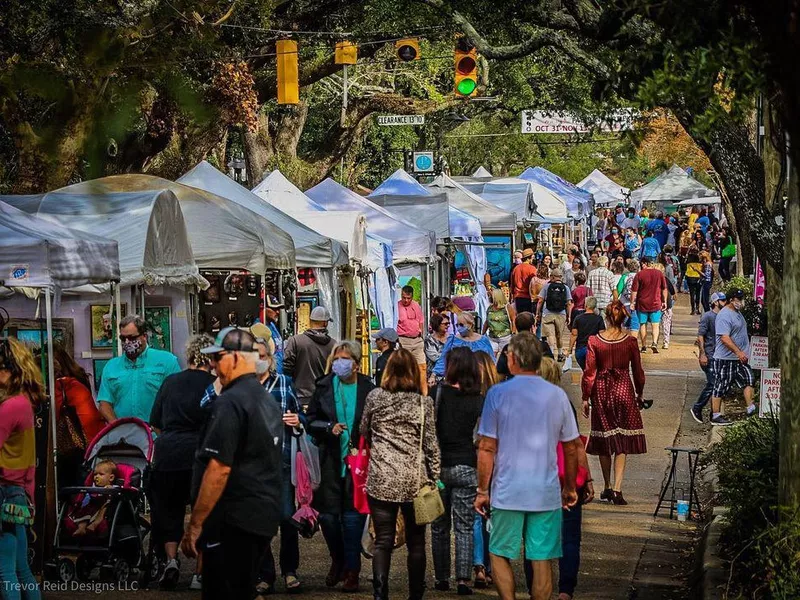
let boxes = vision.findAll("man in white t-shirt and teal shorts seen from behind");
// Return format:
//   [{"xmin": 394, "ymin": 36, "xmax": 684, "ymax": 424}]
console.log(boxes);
[{"xmin": 475, "ymin": 332, "xmax": 580, "ymax": 600}]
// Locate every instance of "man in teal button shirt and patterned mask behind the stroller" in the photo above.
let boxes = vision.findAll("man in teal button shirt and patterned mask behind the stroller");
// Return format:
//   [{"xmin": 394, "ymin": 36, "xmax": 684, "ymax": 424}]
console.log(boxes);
[{"xmin": 97, "ymin": 315, "xmax": 181, "ymax": 423}]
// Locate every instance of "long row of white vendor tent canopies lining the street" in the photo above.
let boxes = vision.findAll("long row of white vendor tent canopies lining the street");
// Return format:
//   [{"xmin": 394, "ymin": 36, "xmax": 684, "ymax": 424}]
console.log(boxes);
[{"xmin": 0, "ymin": 161, "xmax": 718, "ymax": 340}]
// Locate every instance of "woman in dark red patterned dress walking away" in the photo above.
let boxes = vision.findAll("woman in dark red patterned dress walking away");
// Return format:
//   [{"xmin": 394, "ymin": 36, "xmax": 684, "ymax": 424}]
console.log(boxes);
[{"xmin": 581, "ymin": 301, "xmax": 647, "ymax": 505}]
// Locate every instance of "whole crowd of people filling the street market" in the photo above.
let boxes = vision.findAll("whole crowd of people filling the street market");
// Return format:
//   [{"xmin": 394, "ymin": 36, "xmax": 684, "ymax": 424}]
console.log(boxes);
[{"xmin": 0, "ymin": 202, "xmax": 754, "ymax": 600}]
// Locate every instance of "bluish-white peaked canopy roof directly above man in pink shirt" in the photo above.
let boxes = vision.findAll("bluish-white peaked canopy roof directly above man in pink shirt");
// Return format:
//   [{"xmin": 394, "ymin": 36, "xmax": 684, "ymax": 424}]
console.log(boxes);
[{"xmin": 306, "ymin": 178, "xmax": 436, "ymax": 264}]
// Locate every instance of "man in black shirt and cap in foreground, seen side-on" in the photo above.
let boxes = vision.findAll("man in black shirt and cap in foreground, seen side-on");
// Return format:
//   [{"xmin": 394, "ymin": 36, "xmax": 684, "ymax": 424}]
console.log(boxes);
[{"xmin": 181, "ymin": 327, "xmax": 283, "ymax": 600}]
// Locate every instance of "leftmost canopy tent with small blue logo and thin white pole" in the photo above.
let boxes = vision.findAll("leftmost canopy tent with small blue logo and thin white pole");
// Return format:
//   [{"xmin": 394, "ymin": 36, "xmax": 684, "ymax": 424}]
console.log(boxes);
[{"xmin": 0, "ymin": 202, "xmax": 120, "ymax": 514}]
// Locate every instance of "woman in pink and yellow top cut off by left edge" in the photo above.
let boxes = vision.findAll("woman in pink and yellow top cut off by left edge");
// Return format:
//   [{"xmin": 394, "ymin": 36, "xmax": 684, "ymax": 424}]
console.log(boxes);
[{"xmin": 0, "ymin": 338, "xmax": 45, "ymax": 600}]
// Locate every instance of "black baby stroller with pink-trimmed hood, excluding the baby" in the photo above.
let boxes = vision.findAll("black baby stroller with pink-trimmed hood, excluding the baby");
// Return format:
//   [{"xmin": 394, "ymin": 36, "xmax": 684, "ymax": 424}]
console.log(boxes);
[{"xmin": 45, "ymin": 417, "xmax": 153, "ymax": 584}]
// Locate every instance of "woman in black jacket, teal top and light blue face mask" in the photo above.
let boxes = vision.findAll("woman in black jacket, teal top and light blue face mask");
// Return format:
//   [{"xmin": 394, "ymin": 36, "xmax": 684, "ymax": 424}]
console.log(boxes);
[{"xmin": 306, "ymin": 340, "xmax": 375, "ymax": 592}]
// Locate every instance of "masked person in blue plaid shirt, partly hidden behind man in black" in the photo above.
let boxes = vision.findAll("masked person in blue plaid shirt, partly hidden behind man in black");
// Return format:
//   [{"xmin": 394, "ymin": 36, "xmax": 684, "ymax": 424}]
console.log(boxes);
[{"xmin": 250, "ymin": 332, "xmax": 306, "ymax": 596}]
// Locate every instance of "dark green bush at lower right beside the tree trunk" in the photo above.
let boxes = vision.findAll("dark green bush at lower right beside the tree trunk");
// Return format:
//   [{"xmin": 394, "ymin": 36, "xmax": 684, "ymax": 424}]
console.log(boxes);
[{"xmin": 706, "ymin": 418, "xmax": 800, "ymax": 600}]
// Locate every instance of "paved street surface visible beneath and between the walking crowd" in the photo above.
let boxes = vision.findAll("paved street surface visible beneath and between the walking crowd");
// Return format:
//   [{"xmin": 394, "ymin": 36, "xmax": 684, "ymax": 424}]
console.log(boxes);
[{"xmin": 46, "ymin": 295, "xmax": 708, "ymax": 600}]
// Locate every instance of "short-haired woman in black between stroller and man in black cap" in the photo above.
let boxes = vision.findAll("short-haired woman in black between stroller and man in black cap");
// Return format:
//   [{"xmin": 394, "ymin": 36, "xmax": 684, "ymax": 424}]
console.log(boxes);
[{"xmin": 149, "ymin": 334, "xmax": 215, "ymax": 589}]
